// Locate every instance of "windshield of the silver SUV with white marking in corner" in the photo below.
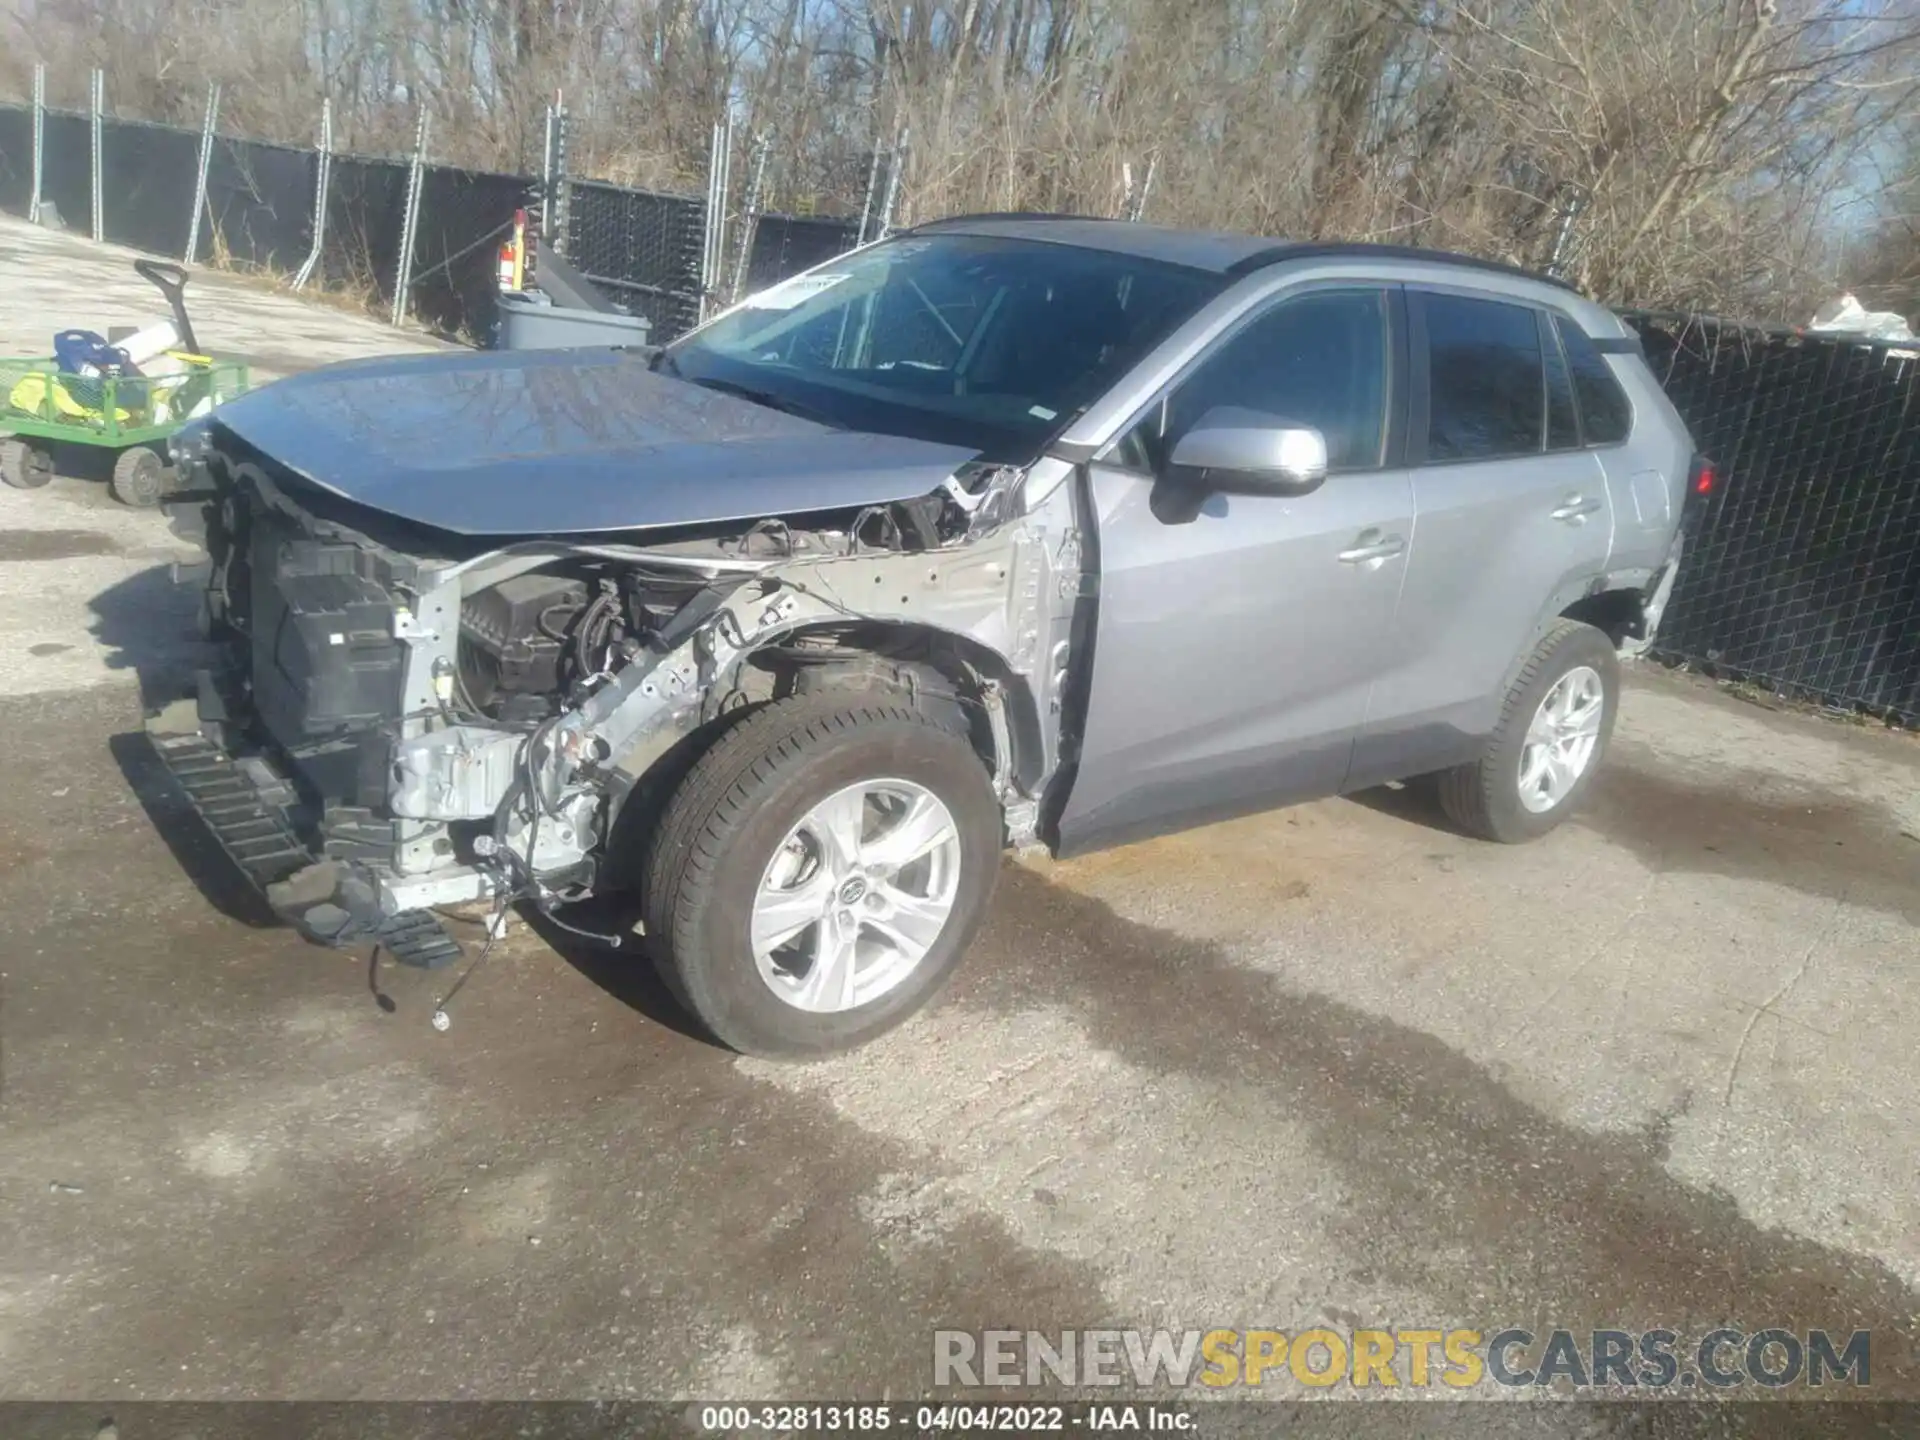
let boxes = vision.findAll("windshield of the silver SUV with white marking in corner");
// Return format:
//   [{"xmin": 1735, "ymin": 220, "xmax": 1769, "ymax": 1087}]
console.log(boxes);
[{"xmin": 660, "ymin": 234, "xmax": 1223, "ymax": 463}]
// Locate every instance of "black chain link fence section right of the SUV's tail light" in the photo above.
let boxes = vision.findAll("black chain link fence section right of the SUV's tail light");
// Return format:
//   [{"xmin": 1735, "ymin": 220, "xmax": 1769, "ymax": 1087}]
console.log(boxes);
[{"xmin": 1628, "ymin": 315, "xmax": 1920, "ymax": 724}]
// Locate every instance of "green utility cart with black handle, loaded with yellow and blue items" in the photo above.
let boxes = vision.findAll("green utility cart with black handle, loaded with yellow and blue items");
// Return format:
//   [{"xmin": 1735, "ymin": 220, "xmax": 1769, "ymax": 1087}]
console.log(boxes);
[{"xmin": 0, "ymin": 259, "xmax": 248, "ymax": 507}]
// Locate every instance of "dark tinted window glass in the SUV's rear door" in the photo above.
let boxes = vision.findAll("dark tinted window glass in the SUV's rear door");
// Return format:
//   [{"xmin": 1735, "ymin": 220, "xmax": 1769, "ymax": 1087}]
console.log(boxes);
[{"xmin": 1427, "ymin": 296, "xmax": 1546, "ymax": 461}]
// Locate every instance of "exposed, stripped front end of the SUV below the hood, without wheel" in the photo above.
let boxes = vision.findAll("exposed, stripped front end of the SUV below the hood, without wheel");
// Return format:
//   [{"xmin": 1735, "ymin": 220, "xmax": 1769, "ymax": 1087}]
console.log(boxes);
[{"xmin": 150, "ymin": 422, "xmax": 1087, "ymax": 966}]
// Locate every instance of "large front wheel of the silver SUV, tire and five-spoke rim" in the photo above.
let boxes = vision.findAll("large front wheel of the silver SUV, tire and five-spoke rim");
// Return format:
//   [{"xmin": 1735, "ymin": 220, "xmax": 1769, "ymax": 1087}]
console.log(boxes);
[{"xmin": 645, "ymin": 689, "xmax": 1002, "ymax": 1058}]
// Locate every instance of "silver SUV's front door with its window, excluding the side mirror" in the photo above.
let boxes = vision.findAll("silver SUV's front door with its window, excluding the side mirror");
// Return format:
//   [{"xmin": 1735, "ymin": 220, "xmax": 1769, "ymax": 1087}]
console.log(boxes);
[{"xmin": 1058, "ymin": 288, "xmax": 1413, "ymax": 854}]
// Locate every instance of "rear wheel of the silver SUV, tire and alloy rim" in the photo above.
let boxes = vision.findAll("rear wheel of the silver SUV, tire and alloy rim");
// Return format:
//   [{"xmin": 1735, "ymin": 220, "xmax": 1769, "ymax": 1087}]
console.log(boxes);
[{"xmin": 1440, "ymin": 620, "xmax": 1620, "ymax": 845}]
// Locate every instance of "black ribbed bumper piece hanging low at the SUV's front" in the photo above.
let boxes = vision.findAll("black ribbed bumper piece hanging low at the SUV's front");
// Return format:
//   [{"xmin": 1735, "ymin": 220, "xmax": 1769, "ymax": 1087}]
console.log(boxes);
[{"xmin": 148, "ymin": 712, "xmax": 461, "ymax": 970}]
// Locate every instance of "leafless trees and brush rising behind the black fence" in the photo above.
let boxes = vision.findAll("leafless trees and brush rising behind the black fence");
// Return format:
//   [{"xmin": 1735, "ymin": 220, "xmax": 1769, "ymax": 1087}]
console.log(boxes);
[{"xmin": 0, "ymin": 0, "xmax": 1920, "ymax": 315}]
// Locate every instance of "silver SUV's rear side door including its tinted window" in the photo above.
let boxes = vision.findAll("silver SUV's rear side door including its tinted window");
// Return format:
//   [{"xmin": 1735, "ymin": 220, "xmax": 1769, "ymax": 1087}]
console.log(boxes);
[{"xmin": 1348, "ymin": 286, "xmax": 1615, "ymax": 789}]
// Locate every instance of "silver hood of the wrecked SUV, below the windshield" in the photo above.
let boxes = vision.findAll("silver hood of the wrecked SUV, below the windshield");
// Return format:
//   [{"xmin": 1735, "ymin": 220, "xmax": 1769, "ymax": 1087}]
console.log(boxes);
[{"xmin": 213, "ymin": 349, "xmax": 975, "ymax": 536}]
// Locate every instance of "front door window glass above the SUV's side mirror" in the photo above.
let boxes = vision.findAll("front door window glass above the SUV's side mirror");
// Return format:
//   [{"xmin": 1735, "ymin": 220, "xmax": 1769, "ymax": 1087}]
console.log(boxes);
[{"xmin": 1116, "ymin": 290, "xmax": 1386, "ymax": 470}]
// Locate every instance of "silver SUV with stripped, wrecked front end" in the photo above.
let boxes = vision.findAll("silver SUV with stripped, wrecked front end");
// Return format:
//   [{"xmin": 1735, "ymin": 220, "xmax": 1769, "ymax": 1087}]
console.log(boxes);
[{"xmin": 161, "ymin": 217, "xmax": 1711, "ymax": 1056}]
